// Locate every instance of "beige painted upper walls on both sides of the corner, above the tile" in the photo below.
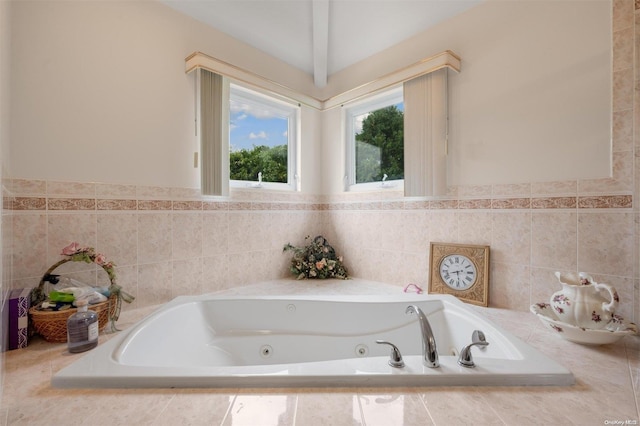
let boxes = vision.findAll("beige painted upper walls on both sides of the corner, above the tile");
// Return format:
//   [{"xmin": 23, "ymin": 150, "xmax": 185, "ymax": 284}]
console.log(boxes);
[{"xmin": 12, "ymin": 1, "xmax": 611, "ymax": 193}]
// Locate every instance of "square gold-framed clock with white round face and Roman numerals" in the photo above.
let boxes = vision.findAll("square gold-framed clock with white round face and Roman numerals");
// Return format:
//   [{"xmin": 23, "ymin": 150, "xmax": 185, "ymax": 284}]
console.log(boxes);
[{"xmin": 429, "ymin": 243, "xmax": 489, "ymax": 306}]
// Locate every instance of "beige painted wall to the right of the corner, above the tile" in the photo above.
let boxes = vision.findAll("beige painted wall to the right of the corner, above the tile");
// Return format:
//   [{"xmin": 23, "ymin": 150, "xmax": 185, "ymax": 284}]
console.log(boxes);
[{"xmin": 325, "ymin": 1, "xmax": 612, "ymax": 193}]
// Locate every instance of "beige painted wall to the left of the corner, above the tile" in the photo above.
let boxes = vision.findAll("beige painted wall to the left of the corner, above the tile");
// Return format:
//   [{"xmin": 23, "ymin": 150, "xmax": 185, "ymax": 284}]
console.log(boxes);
[{"xmin": 12, "ymin": 1, "xmax": 316, "ymax": 188}]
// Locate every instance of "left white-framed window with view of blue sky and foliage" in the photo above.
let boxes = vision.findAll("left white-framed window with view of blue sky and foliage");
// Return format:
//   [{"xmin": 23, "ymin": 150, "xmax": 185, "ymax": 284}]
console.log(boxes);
[{"xmin": 229, "ymin": 84, "xmax": 300, "ymax": 190}]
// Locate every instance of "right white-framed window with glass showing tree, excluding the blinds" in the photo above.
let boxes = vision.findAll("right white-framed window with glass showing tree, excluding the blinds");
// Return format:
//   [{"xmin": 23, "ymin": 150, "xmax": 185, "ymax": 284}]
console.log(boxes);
[{"xmin": 345, "ymin": 87, "xmax": 404, "ymax": 190}]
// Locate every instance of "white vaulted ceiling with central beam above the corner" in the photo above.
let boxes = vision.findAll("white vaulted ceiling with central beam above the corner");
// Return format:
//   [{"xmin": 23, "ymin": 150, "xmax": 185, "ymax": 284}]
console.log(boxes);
[{"xmin": 160, "ymin": 0, "xmax": 483, "ymax": 87}]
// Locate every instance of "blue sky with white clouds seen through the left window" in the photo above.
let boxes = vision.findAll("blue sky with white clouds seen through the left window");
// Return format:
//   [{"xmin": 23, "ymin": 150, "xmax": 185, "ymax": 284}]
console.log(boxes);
[{"xmin": 229, "ymin": 101, "xmax": 288, "ymax": 151}]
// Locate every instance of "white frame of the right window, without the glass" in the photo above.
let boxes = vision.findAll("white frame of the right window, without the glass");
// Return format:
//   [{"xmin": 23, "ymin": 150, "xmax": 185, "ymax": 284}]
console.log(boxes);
[{"xmin": 343, "ymin": 84, "xmax": 404, "ymax": 191}]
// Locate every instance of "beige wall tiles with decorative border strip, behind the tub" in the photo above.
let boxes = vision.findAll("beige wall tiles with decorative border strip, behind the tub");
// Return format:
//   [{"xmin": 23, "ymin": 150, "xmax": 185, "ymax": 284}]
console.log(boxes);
[{"xmin": 5, "ymin": 179, "xmax": 640, "ymax": 321}]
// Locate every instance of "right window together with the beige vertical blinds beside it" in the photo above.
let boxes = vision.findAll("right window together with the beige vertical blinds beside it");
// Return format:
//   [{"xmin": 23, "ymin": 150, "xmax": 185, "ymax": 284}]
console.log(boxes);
[{"xmin": 345, "ymin": 69, "xmax": 448, "ymax": 197}]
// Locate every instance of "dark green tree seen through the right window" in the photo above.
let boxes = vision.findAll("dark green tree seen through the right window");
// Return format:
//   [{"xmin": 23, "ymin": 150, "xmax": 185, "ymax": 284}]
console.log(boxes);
[{"xmin": 356, "ymin": 105, "xmax": 404, "ymax": 183}]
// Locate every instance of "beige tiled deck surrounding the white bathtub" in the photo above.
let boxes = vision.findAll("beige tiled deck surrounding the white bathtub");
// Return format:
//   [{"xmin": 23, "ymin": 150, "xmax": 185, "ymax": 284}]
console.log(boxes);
[{"xmin": 0, "ymin": 281, "xmax": 640, "ymax": 426}]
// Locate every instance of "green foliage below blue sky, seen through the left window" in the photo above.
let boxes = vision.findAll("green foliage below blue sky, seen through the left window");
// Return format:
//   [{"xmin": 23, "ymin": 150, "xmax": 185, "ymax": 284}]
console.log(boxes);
[{"xmin": 229, "ymin": 145, "xmax": 288, "ymax": 183}]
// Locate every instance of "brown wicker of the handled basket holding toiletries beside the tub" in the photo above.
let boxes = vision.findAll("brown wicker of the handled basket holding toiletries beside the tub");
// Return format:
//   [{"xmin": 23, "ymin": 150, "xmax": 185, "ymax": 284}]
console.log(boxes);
[{"xmin": 29, "ymin": 259, "xmax": 117, "ymax": 343}]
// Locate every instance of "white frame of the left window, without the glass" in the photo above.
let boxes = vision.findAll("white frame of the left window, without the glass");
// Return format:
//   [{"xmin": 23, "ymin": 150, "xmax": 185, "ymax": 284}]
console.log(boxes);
[{"xmin": 229, "ymin": 81, "xmax": 301, "ymax": 191}]
